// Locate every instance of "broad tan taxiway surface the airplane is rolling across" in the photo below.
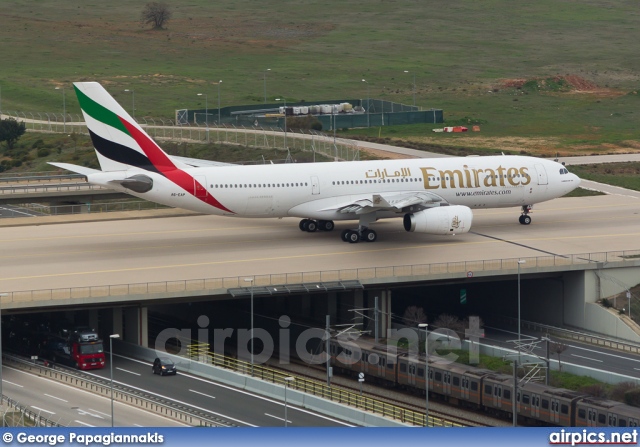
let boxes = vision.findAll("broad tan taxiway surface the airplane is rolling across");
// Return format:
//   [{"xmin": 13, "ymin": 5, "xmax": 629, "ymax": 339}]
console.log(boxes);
[{"xmin": 0, "ymin": 193, "xmax": 640, "ymax": 292}]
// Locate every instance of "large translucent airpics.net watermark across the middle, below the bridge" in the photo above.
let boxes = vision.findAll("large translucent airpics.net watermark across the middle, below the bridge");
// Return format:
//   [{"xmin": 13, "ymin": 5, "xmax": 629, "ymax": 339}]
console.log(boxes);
[{"xmin": 154, "ymin": 315, "xmax": 483, "ymax": 365}]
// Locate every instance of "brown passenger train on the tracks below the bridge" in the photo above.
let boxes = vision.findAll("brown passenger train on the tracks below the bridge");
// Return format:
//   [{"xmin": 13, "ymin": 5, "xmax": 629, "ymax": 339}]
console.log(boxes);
[{"xmin": 329, "ymin": 336, "xmax": 640, "ymax": 427}]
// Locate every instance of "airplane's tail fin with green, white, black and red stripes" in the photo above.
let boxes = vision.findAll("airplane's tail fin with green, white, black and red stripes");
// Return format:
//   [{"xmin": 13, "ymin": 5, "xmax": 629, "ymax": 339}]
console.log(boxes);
[{"xmin": 73, "ymin": 82, "xmax": 187, "ymax": 174}]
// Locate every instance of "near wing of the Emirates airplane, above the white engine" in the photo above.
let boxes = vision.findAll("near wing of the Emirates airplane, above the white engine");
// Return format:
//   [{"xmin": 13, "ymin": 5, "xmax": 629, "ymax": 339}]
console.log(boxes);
[{"xmin": 323, "ymin": 192, "xmax": 444, "ymax": 214}]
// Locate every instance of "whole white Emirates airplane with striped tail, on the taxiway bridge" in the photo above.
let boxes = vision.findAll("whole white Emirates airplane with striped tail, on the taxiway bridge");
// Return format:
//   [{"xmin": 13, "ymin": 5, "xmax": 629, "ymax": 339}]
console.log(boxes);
[{"xmin": 51, "ymin": 82, "xmax": 580, "ymax": 243}]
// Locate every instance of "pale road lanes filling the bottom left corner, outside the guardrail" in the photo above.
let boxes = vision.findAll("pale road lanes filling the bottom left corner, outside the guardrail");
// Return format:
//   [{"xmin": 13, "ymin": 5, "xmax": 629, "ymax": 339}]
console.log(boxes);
[{"xmin": 2, "ymin": 366, "xmax": 185, "ymax": 427}]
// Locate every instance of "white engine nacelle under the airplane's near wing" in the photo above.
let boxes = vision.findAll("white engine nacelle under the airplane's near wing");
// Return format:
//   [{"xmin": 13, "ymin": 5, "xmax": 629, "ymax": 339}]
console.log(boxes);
[{"xmin": 403, "ymin": 205, "xmax": 473, "ymax": 234}]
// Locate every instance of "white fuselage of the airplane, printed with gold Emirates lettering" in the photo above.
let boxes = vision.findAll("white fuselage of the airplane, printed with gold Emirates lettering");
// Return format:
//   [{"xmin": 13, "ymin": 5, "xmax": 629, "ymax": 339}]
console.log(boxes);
[{"xmin": 88, "ymin": 156, "xmax": 580, "ymax": 220}]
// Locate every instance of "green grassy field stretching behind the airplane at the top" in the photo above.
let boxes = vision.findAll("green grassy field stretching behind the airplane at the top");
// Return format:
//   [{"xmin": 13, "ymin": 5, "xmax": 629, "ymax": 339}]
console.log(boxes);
[{"xmin": 0, "ymin": 0, "xmax": 640, "ymax": 155}]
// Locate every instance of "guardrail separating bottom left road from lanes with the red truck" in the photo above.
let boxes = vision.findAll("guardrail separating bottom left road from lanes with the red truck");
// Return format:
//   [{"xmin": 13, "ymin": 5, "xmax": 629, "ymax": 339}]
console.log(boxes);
[{"xmin": 5, "ymin": 356, "xmax": 234, "ymax": 427}]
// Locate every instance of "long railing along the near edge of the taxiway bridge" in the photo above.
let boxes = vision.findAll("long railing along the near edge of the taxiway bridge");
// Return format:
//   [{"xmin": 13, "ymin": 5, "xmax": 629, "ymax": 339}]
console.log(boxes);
[{"xmin": 0, "ymin": 250, "xmax": 640, "ymax": 303}]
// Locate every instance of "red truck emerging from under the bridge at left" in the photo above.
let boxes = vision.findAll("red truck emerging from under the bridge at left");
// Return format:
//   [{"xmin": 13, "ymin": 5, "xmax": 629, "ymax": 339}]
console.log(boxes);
[{"xmin": 43, "ymin": 331, "xmax": 105, "ymax": 370}]
